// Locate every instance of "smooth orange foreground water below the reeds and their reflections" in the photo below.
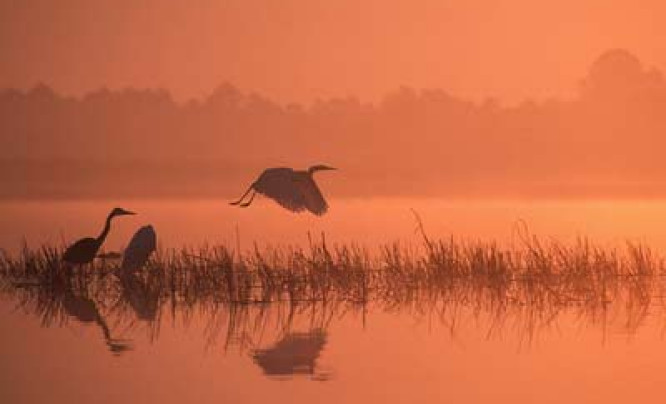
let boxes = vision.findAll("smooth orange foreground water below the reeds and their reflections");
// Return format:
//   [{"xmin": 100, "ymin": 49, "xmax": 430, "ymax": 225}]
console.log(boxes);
[{"xmin": 0, "ymin": 294, "xmax": 666, "ymax": 403}]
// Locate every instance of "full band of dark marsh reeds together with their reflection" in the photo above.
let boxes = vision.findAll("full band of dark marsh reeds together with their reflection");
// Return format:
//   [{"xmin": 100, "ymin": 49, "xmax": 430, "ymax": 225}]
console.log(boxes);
[{"xmin": 0, "ymin": 224, "xmax": 666, "ymax": 353}]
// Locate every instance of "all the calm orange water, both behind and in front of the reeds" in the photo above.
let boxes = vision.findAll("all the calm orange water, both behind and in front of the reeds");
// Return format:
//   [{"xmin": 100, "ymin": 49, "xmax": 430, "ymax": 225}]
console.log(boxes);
[{"xmin": 0, "ymin": 200, "xmax": 666, "ymax": 403}]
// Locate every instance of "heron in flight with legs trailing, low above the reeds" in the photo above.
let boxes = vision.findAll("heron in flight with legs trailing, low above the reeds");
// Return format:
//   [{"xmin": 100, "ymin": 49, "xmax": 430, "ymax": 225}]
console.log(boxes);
[{"xmin": 230, "ymin": 164, "xmax": 335, "ymax": 216}]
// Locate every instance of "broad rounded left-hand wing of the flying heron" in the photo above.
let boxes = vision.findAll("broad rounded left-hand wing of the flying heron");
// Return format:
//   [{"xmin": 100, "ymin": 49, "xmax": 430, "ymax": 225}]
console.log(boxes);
[{"xmin": 254, "ymin": 168, "xmax": 306, "ymax": 212}]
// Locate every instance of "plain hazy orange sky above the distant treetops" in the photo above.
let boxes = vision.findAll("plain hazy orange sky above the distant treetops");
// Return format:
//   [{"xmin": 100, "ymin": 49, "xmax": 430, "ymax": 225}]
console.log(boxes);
[{"xmin": 0, "ymin": 0, "xmax": 666, "ymax": 101}]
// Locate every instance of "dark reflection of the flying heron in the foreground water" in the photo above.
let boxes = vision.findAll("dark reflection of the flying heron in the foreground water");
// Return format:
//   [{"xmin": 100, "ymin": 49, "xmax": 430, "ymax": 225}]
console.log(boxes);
[{"xmin": 252, "ymin": 328, "xmax": 330, "ymax": 380}]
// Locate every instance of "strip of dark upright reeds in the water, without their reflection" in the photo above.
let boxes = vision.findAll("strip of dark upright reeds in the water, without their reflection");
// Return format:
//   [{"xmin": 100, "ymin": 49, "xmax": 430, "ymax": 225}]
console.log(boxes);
[{"xmin": 0, "ymin": 235, "xmax": 664, "ymax": 305}]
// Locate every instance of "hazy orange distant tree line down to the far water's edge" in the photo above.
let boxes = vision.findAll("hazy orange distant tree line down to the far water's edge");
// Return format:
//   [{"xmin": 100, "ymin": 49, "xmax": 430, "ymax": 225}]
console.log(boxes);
[{"xmin": 0, "ymin": 50, "xmax": 666, "ymax": 198}]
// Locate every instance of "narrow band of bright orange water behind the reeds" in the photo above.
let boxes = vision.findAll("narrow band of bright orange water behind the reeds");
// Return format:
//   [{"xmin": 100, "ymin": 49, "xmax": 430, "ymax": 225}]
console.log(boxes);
[{"xmin": 0, "ymin": 199, "xmax": 666, "ymax": 250}]
